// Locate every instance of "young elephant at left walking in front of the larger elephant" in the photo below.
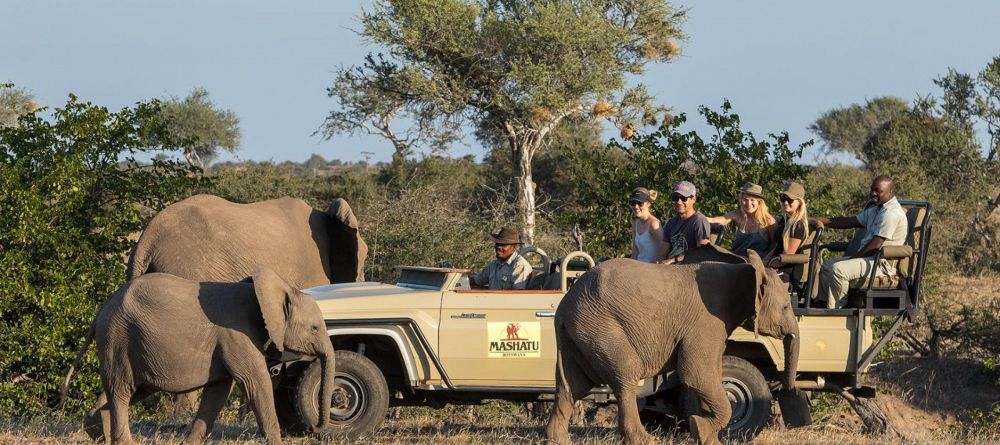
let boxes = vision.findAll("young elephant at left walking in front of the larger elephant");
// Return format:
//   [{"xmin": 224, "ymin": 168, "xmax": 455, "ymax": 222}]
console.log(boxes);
[{"xmin": 94, "ymin": 269, "xmax": 334, "ymax": 444}]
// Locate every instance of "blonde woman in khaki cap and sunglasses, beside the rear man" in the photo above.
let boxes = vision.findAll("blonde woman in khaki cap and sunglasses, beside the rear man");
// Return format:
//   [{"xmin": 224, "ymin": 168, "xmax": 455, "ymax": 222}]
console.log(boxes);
[{"xmin": 763, "ymin": 182, "xmax": 809, "ymax": 268}]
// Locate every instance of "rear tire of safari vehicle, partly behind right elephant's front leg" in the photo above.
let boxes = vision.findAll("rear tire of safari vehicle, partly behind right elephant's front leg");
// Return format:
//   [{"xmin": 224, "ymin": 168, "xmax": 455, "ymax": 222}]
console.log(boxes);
[{"xmin": 680, "ymin": 355, "xmax": 772, "ymax": 441}]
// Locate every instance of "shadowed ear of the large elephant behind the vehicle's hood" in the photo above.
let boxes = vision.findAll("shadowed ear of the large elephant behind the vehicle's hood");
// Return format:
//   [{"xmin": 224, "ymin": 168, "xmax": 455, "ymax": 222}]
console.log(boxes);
[{"xmin": 326, "ymin": 198, "xmax": 368, "ymax": 283}]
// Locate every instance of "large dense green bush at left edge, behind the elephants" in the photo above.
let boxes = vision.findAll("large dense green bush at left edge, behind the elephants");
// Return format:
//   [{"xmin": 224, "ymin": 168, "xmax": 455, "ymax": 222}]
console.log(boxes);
[{"xmin": 0, "ymin": 92, "xmax": 196, "ymax": 417}]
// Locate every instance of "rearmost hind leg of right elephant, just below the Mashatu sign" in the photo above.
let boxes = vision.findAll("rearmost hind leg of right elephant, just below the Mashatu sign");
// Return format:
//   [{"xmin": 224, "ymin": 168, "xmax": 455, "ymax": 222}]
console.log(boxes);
[{"xmin": 545, "ymin": 342, "xmax": 594, "ymax": 444}]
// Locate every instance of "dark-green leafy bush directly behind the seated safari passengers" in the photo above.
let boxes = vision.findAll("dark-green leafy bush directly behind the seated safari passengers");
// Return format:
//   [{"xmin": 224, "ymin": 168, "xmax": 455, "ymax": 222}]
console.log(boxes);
[{"xmin": 564, "ymin": 101, "xmax": 811, "ymax": 257}]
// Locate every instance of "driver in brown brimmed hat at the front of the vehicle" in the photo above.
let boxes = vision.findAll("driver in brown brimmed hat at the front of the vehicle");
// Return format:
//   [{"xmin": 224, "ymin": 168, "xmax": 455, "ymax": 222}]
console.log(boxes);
[{"xmin": 471, "ymin": 227, "xmax": 531, "ymax": 290}]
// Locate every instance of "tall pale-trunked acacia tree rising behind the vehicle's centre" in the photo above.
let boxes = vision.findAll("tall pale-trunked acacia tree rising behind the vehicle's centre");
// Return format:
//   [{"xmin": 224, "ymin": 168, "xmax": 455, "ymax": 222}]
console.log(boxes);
[{"xmin": 325, "ymin": 0, "xmax": 685, "ymax": 243}]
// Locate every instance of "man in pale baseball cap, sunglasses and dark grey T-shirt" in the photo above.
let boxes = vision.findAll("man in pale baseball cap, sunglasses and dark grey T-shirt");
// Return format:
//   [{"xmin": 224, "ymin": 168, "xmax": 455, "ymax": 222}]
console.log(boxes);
[{"xmin": 659, "ymin": 181, "xmax": 712, "ymax": 264}]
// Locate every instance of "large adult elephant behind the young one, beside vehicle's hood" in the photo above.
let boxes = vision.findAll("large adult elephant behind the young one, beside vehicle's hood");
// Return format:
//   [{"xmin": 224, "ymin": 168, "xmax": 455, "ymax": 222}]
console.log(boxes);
[{"xmin": 127, "ymin": 195, "xmax": 368, "ymax": 289}]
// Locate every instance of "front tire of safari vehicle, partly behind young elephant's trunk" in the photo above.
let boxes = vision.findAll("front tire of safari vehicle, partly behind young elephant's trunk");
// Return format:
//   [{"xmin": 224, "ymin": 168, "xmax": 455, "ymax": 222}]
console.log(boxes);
[{"xmin": 288, "ymin": 351, "xmax": 389, "ymax": 438}]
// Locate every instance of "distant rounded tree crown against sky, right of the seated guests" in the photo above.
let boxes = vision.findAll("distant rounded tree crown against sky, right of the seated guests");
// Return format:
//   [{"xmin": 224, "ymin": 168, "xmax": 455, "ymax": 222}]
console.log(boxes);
[{"xmin": 809, "ymin": 96, "xmax": 910, "ymax": 163}]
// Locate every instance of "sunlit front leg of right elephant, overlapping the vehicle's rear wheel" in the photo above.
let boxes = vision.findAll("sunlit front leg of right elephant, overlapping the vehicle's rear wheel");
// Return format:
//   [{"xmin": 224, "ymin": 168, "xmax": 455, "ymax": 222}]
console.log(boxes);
[{"xmin": 677, "ymin": 346, "xmax": 732, "ymax": 445}]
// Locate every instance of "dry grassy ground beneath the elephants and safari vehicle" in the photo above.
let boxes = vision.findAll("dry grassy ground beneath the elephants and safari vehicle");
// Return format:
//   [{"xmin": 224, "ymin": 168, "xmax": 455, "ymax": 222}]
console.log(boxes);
[{"xmin": 7, "ymin": 277, "xmax": 1000, "ymax": 445}]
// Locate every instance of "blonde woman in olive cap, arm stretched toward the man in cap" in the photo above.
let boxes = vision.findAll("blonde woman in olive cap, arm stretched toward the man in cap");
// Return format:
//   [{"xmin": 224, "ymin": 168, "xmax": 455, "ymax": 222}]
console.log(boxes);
[{"xmin": 708, "ymin": 182, "xmax": 775, "ymax": 256}]
